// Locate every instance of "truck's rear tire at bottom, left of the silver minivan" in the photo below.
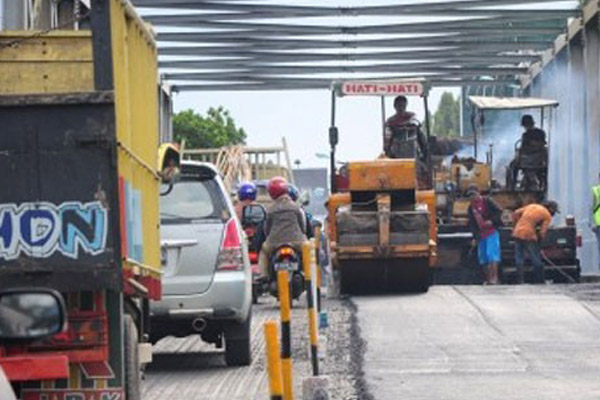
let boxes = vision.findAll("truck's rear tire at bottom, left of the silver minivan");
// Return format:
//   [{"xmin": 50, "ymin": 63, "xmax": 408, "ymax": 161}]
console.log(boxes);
[{"xmin": 123, "ymin": 315, "xmax": 142, "ymax": 400}]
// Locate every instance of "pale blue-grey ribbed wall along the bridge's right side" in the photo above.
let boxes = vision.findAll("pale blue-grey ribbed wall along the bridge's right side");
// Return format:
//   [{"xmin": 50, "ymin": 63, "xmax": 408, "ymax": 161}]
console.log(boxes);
[{"xmin": 528, "ymin": 13, "xmax": 600, "ymax": 274}]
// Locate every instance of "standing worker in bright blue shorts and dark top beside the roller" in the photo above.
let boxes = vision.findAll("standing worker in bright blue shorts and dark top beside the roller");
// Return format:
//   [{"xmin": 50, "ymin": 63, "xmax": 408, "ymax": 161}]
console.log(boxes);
[{"xmin": 467, "ymin": 185, "xmax": 502, "ymax": 285}]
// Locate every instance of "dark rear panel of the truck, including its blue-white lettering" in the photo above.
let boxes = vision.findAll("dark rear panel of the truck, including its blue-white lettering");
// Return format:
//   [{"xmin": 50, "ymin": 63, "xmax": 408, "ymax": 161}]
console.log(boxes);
[{"xmin": 0, "ymin": 92, "xmax": 121, "ymax": 291}]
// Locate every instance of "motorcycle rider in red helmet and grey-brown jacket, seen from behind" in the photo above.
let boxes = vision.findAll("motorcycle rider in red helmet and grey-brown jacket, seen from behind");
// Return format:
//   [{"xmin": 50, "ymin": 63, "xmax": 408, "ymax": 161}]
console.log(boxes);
[{"xmin": 258, "ymin": 176, "xmax": 306, "ymax": 276}]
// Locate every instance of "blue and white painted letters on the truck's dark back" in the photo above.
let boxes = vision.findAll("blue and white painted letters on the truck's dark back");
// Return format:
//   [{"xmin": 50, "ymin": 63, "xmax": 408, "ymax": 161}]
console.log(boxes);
[{"xmin": 0, "ymin": 201, "xmax": 108, "ymax": 260}]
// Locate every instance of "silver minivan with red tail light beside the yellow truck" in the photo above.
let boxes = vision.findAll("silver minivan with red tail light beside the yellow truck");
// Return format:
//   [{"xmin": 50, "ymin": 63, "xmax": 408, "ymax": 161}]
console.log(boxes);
[{"xmin": 150, "ymin": 161, "xmax": 252, "ymax": 365}]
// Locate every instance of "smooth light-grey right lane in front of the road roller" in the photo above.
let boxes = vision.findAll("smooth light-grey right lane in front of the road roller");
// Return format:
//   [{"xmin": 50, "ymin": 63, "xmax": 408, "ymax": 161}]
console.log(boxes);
[{"xmin": 353, "ymin": 286, "xmax": 600, "ymax": 400}]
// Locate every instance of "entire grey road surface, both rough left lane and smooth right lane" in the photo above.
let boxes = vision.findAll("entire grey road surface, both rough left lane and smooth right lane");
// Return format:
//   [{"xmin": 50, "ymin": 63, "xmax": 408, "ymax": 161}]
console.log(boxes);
[{"xmin": 144, "ymin": 284, "xmax": 600, "ymax": 400}]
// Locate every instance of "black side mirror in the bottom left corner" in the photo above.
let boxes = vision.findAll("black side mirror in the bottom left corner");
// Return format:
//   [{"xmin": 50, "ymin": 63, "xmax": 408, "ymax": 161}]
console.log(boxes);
[{"xmin": 0, "ymin": 289, "xmax": 67, "ymax": 342}]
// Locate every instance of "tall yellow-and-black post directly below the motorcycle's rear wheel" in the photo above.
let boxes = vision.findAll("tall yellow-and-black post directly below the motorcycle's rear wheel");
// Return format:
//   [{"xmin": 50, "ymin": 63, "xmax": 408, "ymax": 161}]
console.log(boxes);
[{"xmin": 277, "ymin": 271, "xmax": 294, "ymax": 400}]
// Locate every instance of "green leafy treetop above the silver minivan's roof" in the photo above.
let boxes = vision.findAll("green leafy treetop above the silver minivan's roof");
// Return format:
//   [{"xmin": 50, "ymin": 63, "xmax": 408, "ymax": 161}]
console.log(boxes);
[{"xmin": 173, "ymin": 107, "xmax": 246, "ymax": 149}]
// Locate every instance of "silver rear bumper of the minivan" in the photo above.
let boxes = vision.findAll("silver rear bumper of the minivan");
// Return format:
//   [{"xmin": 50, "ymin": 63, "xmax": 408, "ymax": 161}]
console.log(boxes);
[{"xmin": 150, "ymin": 271, "xmax": 252, "ymax": 322}]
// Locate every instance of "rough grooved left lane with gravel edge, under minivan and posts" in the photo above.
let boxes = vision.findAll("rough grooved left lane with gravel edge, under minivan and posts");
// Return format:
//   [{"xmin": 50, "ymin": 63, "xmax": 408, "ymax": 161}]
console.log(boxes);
[{"xmin": 141, "ymin": 297, "xmax": 357, "ymax": 400}]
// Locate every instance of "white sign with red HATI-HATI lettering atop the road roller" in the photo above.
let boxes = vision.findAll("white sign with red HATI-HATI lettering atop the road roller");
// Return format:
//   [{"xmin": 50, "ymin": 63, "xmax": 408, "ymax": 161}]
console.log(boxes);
[{"xmin": 340, "ymin": 81, "xmax": 424, "ymax": 96}]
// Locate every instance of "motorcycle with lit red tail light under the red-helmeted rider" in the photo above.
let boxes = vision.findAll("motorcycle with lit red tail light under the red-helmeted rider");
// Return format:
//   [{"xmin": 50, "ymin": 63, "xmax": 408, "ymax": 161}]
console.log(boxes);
[{"xmin": 269, "ymin": 244, "xmax": 304, "ymax": 306}]
